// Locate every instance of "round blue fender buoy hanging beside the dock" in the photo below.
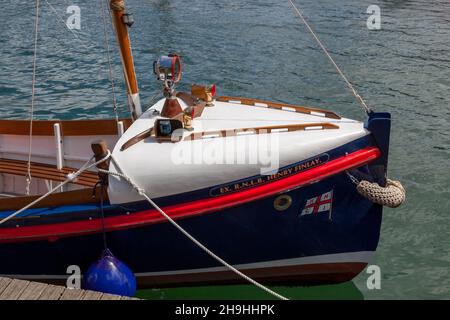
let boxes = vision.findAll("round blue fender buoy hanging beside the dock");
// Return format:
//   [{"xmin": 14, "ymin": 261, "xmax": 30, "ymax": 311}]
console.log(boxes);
[{"xmin": 83, "ymin": 249, "xmax": 136, "ymax": 297}]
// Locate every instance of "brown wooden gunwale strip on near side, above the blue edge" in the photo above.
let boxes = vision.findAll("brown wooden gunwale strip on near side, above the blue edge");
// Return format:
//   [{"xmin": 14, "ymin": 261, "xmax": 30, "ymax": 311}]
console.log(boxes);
[{"xmin": 0, "ymin": 187, "xmax": 108, "ymax": 212}]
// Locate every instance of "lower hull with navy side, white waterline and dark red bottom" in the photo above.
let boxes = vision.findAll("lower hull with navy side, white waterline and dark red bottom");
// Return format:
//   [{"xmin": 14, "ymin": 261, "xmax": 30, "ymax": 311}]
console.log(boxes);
[{"xmin": 0, "ymin": 114, "xmax": 389, "ymax": 288}]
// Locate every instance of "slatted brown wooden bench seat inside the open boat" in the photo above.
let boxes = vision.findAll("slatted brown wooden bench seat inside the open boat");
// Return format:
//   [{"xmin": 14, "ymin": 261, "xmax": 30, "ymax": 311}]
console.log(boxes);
[{"xmin": 0, "ymin": 159, "xmax": 98, "ymax": 187}]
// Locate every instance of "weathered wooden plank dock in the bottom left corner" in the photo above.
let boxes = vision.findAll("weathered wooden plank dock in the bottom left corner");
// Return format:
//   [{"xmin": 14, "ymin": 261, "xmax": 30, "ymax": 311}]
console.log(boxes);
[{"xmin": 0, "ymin": 277, "xmax": 139, "ymax": 300}]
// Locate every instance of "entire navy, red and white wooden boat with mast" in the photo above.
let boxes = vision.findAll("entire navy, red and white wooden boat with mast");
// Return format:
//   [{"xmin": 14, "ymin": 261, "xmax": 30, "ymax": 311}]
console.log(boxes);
[{"xmin": 0, "ymin": 0, "xmax": 390, "ymax": 287}]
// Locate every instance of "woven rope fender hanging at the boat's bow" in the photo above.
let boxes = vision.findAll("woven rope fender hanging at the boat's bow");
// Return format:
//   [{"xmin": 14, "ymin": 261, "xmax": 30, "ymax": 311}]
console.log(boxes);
[{"xmin": 356, "ymin": 179, "xmax": 406, "ymax": 208}]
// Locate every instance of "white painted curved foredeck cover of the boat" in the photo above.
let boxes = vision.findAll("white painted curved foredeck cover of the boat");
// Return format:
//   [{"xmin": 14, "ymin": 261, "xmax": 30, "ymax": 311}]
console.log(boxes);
[{"xmin": 108, "ymin": 100, "xmax": 368, "ymax": 204}]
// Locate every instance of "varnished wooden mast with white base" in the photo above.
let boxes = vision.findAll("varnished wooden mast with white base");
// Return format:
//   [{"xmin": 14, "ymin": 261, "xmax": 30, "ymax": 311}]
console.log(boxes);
[{"xmin": 109, "ymin": 0, "xmax": 142, "ymax": 121}]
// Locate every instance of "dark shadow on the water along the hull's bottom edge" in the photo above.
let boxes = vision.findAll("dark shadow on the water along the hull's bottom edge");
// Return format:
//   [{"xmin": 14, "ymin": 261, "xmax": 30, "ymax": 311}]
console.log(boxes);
[{"xmin": 136, "ymin": 281, "xmax": 364, "ymax": 300}]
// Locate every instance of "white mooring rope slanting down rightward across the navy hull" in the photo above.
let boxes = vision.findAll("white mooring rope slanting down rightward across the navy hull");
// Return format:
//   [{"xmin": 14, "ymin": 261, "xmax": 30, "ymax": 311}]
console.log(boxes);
[{"xmin": 98, "ymin": 155, "xmax": 289, "ymax": 300}]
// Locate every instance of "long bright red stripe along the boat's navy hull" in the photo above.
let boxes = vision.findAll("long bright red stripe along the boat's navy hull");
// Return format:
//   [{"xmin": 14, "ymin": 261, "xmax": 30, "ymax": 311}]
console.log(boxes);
[{"xmin": 0, "ymin": 147, "xmax": 381, "ymax": 243}]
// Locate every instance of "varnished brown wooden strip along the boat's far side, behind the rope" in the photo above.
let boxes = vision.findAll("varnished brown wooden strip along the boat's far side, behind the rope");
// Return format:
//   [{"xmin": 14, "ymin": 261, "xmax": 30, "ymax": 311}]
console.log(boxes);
[{"xmin": 0, "ymin": 118, "xmax": 131, "ymax": 136}]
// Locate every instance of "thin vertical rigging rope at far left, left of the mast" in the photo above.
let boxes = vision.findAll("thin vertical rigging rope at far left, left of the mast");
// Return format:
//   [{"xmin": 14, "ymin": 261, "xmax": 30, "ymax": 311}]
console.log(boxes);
[{"xmin": 25, "ymin": 0, "xmax": 40, "ymax": 195}]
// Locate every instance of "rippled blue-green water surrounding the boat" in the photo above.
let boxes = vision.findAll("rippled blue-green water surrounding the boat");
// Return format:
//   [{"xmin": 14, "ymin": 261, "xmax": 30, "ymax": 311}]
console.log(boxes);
[{"xmin": 0, "ymin": 0, "xmax": 450, "ymax": 299}]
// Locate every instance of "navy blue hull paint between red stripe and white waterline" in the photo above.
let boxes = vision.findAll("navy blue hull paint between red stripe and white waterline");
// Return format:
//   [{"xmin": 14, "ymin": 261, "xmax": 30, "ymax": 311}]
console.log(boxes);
[{"xmin": 0, "ymin": 170, "xmax": 382, "ymax": 286}]
